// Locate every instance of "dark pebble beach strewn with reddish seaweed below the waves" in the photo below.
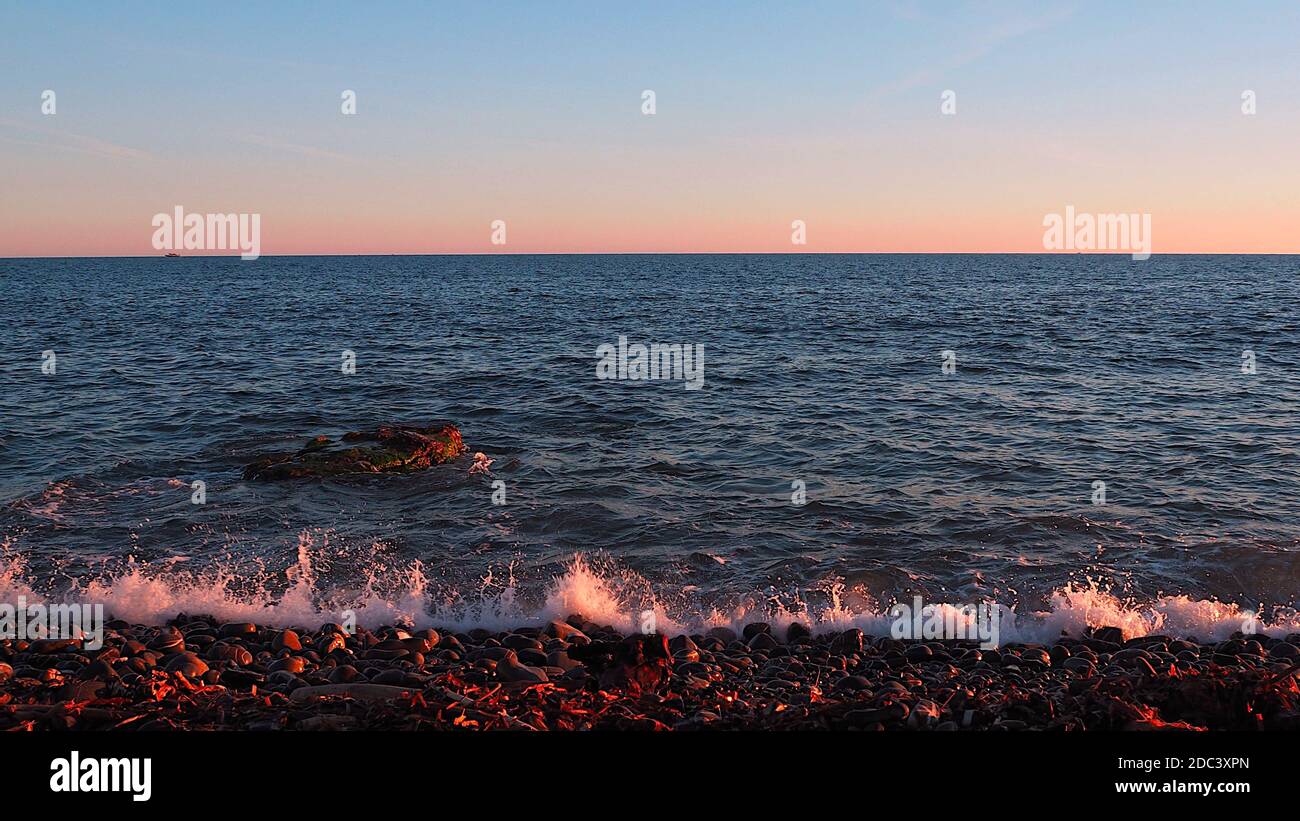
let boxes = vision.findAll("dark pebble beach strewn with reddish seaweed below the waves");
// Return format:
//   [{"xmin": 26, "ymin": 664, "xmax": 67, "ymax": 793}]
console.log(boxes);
[{"xmin": 0, "ymin": 616, "xmax": 1300, "ymax": 731}]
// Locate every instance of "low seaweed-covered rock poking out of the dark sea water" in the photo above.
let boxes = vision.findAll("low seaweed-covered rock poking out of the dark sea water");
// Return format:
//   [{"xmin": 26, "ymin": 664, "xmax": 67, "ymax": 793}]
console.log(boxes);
[{"xmin": 244, "ymin": 422, "xmax": 465, "ymax": 481}]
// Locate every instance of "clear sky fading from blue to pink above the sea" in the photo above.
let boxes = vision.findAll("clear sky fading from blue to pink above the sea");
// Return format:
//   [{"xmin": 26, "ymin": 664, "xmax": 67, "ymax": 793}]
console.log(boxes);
[{"xmin": 0, "ymin": 0, "xmax": 1300, "ymax": 257}]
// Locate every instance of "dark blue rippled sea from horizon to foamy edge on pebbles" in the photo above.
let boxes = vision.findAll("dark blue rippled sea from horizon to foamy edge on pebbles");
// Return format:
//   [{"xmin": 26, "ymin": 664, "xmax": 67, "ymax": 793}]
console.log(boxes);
[{"xmin": 0, "ymin": 255, "xmax": 1300, "ymax": 629}]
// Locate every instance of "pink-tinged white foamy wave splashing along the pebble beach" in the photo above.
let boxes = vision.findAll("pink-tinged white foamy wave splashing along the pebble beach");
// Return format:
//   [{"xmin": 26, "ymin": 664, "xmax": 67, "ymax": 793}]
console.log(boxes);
[{"xmin": 0, "ymin": 531, "xmax": 1300, "ymax": 643}]
